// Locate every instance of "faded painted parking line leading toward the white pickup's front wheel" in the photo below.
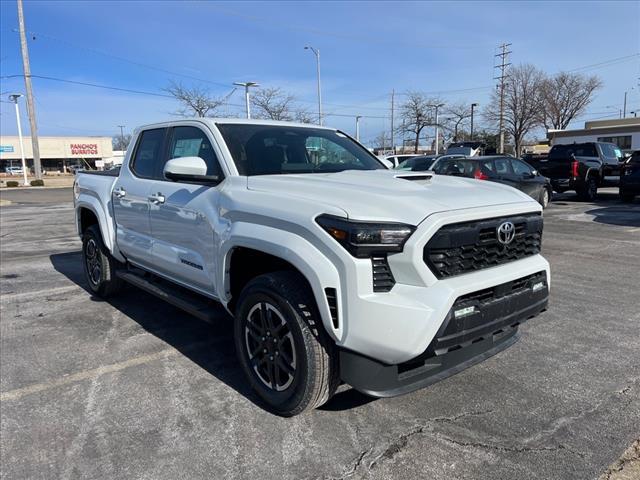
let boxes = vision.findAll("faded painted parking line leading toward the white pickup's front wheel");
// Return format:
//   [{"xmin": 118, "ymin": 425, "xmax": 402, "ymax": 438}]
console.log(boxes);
[{"xmin": 0, "ymin": 341, "xmax": 212, "ymax": 402}]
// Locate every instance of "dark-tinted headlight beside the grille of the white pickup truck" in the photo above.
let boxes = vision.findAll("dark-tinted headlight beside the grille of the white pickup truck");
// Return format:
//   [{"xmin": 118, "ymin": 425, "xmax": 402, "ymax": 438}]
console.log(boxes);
[{"xmin": 316, "ymin": 215, "xmax": 415, "ymax": 258}]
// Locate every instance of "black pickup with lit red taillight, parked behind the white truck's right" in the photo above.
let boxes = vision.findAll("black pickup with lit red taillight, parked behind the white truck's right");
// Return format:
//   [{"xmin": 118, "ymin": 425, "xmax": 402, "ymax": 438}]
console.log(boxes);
[{"xmin": 530, "ymin": 142, "xmax": 623, "ymax": 201}]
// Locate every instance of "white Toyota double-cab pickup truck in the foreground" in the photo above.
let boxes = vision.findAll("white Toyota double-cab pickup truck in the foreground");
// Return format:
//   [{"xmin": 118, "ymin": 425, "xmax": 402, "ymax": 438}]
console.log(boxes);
[{"xmin": 74, "ymin": 119, "xmax": 549, "ymax": 416}]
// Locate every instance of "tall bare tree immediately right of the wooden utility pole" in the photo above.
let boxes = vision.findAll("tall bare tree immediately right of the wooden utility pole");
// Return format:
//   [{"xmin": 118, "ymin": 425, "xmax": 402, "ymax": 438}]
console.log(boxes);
[{"xmin": 484, "ymin": 64, "xmax": 544, "ymax": 155}]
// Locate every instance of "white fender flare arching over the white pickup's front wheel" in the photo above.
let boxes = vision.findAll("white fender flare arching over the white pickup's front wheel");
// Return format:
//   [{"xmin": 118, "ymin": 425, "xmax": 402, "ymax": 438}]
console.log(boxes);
[{"xmin": 216, "ymin": 222, "xmax": 344, "ymax": 342}]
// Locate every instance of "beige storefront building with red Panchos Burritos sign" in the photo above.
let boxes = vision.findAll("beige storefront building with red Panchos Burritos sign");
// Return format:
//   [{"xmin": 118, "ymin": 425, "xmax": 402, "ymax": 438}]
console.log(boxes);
[{"xmin": 0, "ymin": 136, "xmax": 113, "ymax": 173}]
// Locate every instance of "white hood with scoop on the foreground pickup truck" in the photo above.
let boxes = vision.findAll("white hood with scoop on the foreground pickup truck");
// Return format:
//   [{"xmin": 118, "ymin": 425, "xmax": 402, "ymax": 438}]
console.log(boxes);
[{"xmin": 247, "ymin": 170, "xmax": 538, "ymax": 225}]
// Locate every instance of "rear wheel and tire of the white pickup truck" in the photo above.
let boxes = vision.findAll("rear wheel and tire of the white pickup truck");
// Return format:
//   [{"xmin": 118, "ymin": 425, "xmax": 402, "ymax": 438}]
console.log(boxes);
[{"xmin": 82, "ymin": 225, "xmax": 122, "ymax": 298}]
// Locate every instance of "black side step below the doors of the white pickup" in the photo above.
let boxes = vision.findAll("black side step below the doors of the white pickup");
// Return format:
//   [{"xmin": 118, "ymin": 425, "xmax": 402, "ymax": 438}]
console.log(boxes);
[{"xmin": 116, "ymin": 270, "xmax": 228, "ymax": 323}]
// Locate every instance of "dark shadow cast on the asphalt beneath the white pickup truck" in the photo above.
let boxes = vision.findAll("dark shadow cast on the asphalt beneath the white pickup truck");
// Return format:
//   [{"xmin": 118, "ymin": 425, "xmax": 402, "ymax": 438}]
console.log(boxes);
[{"xmin": 49, "ymin": 251, "xmax": 375, "ymax": 411}]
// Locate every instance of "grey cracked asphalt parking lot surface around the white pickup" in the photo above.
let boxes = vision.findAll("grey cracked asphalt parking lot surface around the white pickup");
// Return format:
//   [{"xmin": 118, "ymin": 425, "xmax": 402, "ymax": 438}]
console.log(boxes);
[{"xmin": 0, "ymin": 189, "xmax": 640, "ymax": 479}]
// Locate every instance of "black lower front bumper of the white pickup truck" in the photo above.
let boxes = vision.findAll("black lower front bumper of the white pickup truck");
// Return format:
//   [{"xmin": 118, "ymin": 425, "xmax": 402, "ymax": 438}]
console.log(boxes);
[{"xmin": 340, "ymin": 271, "xmax": 549, "ymax": 397}]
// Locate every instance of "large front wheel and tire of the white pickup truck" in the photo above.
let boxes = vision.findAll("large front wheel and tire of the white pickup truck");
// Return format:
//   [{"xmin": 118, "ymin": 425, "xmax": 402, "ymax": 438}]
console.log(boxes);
[{"xmin": 234, "ymin": 272, "xmax": 339, "ymax": 417}]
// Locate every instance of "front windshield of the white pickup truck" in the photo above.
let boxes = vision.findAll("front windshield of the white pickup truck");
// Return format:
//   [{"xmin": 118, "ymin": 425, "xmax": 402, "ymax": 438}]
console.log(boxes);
[{"xmin": 218, "ymin": 123, "xmax": 385, "ymax": 176}]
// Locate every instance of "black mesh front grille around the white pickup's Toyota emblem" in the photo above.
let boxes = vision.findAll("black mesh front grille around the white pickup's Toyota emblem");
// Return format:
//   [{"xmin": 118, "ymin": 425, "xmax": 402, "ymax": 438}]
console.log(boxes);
[{"xmin": 423, "ymin": 213, "xmax": 542, "ymax": 278}]
